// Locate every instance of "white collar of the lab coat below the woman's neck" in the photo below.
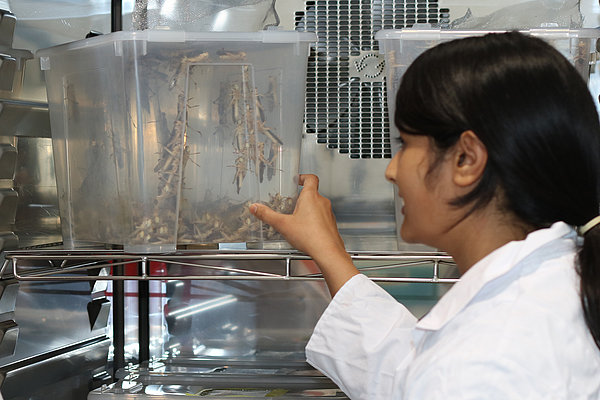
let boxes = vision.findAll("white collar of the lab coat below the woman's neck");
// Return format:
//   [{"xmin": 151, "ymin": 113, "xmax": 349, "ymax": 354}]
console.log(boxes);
[{"xmin": 416, "ymin": 222, "xmax": 576, "ymax": 330}]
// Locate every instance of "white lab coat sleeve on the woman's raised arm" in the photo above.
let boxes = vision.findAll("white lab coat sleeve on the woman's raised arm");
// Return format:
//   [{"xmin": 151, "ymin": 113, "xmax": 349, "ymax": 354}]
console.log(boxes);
[{"xmin": 306, "ymin": 274, "xmax": 417, "ymax": 400}]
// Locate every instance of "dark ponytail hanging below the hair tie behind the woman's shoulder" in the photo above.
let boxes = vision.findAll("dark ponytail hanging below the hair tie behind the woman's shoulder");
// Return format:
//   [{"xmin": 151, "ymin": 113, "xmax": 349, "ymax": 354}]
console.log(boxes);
[{"xmin": 578, "ymin": 224, "xmax": 600, "ymax": 349}]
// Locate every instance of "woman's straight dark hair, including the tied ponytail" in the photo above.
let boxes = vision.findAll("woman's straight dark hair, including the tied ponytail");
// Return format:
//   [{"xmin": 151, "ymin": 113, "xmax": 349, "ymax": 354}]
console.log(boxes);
[{"xmin": 395, "ymin": 32, "xmax": 600, "ymax": 348}]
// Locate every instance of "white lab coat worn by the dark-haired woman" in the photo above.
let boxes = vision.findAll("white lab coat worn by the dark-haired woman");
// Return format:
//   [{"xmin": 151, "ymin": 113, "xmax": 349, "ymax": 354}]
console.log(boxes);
[{"xmin": 306, "ymin": 222, "xmax": 600, "ymax": 400}]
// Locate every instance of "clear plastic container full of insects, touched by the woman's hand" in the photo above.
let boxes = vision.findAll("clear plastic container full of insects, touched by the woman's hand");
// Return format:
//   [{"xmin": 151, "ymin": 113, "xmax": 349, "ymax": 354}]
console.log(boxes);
[{"xmin": 36, "ymin": 30, "xmax": 316, "ymax": 252}]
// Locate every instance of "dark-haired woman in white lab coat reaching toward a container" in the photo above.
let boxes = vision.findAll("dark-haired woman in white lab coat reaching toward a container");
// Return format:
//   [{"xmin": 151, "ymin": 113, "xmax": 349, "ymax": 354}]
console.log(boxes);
[{"xmin": 251, "ymin": 32, "xmax": 600, "ymax": 399}]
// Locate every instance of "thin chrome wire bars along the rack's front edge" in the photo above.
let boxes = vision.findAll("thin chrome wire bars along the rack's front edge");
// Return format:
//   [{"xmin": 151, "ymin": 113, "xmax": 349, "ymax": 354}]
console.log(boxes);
[{"xmin": 0, "ymin": 250, "xmax": 458, "ymax": 283}]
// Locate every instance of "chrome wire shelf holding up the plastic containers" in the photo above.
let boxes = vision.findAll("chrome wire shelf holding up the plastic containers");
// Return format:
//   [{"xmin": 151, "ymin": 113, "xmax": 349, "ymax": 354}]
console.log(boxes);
[{"xmin": 0, "ymin": 249, "xmax": 458, "ymax": 283}]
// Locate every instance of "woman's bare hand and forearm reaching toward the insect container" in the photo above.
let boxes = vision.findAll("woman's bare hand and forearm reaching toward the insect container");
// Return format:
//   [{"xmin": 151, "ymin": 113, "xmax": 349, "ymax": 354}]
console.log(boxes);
[{"xmin": 250, "ymin": 175, "xmax": 359, "ymax": 296}]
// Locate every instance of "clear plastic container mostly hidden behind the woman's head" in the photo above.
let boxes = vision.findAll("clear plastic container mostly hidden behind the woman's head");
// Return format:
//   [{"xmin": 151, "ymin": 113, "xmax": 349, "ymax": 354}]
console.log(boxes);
[{"xmin": 375, "ymin": 27, "xmax": 600, "ymax": 248}]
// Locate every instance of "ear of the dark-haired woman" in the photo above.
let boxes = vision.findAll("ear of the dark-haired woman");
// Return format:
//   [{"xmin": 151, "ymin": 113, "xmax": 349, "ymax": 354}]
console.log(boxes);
[{"xmin": 452, "ymin": 131, "xmax": 488, "ymax": 187}]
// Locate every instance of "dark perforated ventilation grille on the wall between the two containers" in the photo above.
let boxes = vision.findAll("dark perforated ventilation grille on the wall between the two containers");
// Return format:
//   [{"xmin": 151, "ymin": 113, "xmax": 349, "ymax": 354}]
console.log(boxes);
[{"xmin": 295, "ymin": 0, "xmax": 449, "ymax": 158}]
